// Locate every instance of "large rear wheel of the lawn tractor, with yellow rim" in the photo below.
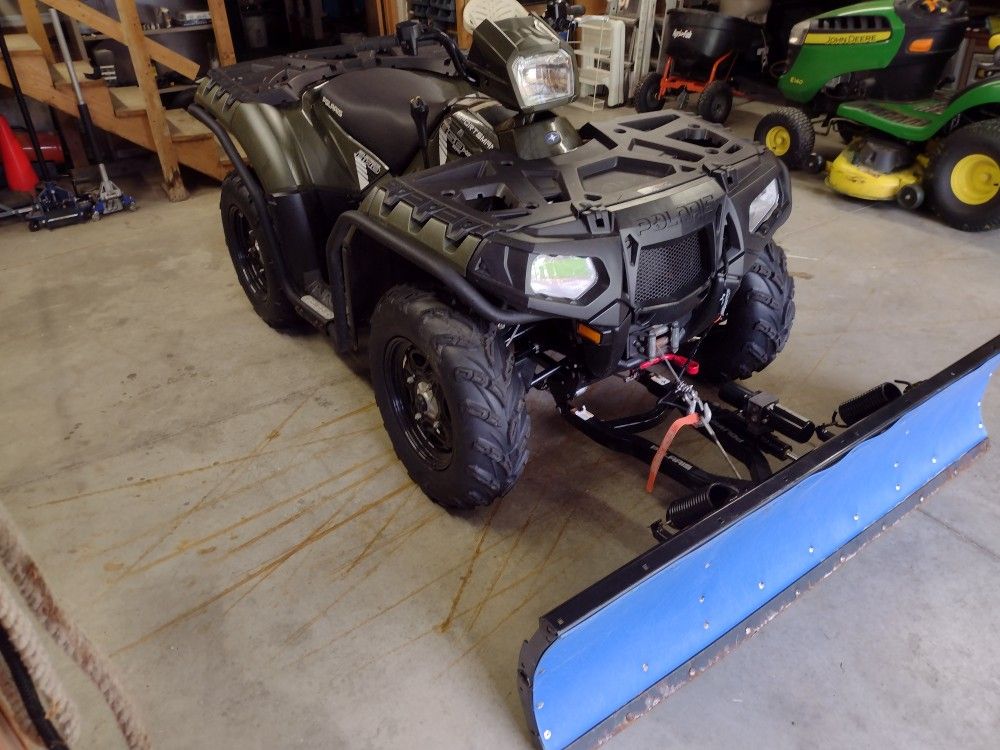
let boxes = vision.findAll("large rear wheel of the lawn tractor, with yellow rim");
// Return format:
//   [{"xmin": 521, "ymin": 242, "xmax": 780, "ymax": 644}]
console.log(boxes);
[{"xmin": 924, "ymin": 120, "xmax": 1000, "ymax": 232}]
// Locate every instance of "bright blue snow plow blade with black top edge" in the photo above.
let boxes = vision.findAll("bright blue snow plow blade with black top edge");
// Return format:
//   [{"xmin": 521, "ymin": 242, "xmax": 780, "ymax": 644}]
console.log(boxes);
[{"xmin": 518, "ymin": 337, "xmax": 1000, "ymax": 750}]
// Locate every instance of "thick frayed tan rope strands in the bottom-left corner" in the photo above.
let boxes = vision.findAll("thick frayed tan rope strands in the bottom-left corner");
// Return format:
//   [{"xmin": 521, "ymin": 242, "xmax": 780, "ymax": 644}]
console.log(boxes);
[{"xmin": 0, "ymin": 506, "xmax": 150, "ymax": 750}]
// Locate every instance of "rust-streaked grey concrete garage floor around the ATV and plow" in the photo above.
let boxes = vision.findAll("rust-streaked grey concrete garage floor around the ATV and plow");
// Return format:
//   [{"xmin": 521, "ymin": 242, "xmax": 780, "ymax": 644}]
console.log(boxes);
[{"xmin": 0, "ymin": 109, "xmax": 1000, "ymax": 749}]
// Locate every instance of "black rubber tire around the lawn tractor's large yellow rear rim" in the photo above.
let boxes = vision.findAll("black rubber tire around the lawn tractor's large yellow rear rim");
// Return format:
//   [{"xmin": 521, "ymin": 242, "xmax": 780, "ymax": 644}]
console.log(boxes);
[{"xmin": 924, "ymin": 120, "xmax": 1000, "ymax": 232}]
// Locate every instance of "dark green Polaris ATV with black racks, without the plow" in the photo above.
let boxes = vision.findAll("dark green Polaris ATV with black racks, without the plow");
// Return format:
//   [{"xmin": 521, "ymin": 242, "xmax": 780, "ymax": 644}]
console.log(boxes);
[{"xmin": 190, "ymin": 16, "xmax": 795, "ymax": 508}]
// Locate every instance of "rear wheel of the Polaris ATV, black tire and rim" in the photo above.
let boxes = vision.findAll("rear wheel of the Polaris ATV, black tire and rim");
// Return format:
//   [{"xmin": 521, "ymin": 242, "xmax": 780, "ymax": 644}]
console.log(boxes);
[{"xmin": 219, "ymin": 172, "xmax": 303, "ymax": 329}]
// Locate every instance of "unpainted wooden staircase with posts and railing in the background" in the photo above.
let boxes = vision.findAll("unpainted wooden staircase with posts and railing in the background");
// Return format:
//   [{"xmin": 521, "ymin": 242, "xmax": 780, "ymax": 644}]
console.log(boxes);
[{"xmin": 0, "ymin": 0, "xmax": 236, "ymax": 201}]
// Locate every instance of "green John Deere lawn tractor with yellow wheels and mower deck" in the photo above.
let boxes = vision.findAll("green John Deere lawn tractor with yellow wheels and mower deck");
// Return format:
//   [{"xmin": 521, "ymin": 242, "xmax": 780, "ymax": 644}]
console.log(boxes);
[{"xmin": 756, "ymin": 0, "xmax": 1000, "ymax": 232}]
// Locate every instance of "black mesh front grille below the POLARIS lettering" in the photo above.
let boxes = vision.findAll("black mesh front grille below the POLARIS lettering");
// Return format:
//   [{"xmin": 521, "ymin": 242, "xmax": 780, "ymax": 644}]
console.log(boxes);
[{"xmin": 635, "ymin": 230, "xmax": 711, "ymax": 308}]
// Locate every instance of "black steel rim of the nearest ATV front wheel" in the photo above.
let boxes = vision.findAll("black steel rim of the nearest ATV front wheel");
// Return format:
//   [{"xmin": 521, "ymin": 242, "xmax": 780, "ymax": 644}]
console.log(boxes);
[{"xmin": 383, "ymin": 338, "xmax": 452, "ymax": 471}]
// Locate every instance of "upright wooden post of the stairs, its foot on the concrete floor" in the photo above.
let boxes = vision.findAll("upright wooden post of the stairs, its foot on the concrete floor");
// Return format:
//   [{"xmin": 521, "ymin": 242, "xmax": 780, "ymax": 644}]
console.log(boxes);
[{"xmin": 113, "ymin": 0, "xmax": 188, "ymax": 201}]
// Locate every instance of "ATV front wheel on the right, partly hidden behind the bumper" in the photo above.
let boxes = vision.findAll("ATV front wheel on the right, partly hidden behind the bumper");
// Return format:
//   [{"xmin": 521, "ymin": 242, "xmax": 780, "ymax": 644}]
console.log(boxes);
[{"xmin": 698, "ymin": 243, "xmax": 795, "ymax": 381}]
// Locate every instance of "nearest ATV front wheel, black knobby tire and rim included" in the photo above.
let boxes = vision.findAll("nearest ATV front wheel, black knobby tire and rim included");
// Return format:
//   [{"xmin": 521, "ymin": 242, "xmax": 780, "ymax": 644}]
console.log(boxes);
[{"xmin": 368, "ymin": 285, "xmax": 531, "ymax": 509}]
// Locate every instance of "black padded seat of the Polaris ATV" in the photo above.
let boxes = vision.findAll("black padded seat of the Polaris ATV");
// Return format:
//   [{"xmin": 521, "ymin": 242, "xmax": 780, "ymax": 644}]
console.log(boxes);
[{"xmin": 320, "ymin": 68, "xmax": 472, "ymax": 174}]
